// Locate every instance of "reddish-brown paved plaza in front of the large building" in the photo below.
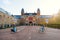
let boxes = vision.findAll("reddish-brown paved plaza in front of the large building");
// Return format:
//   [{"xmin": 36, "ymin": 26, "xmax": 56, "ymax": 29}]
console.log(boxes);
[{"xmin": 0, "ymin": 26, "xmax": 60, "ymax": 40}]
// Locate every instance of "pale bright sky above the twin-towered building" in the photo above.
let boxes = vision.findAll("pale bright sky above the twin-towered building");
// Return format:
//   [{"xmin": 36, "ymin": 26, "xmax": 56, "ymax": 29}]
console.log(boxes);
[{"xmin": 0, "ymin": 0, "xmax": 60, "ymax": 15}]
